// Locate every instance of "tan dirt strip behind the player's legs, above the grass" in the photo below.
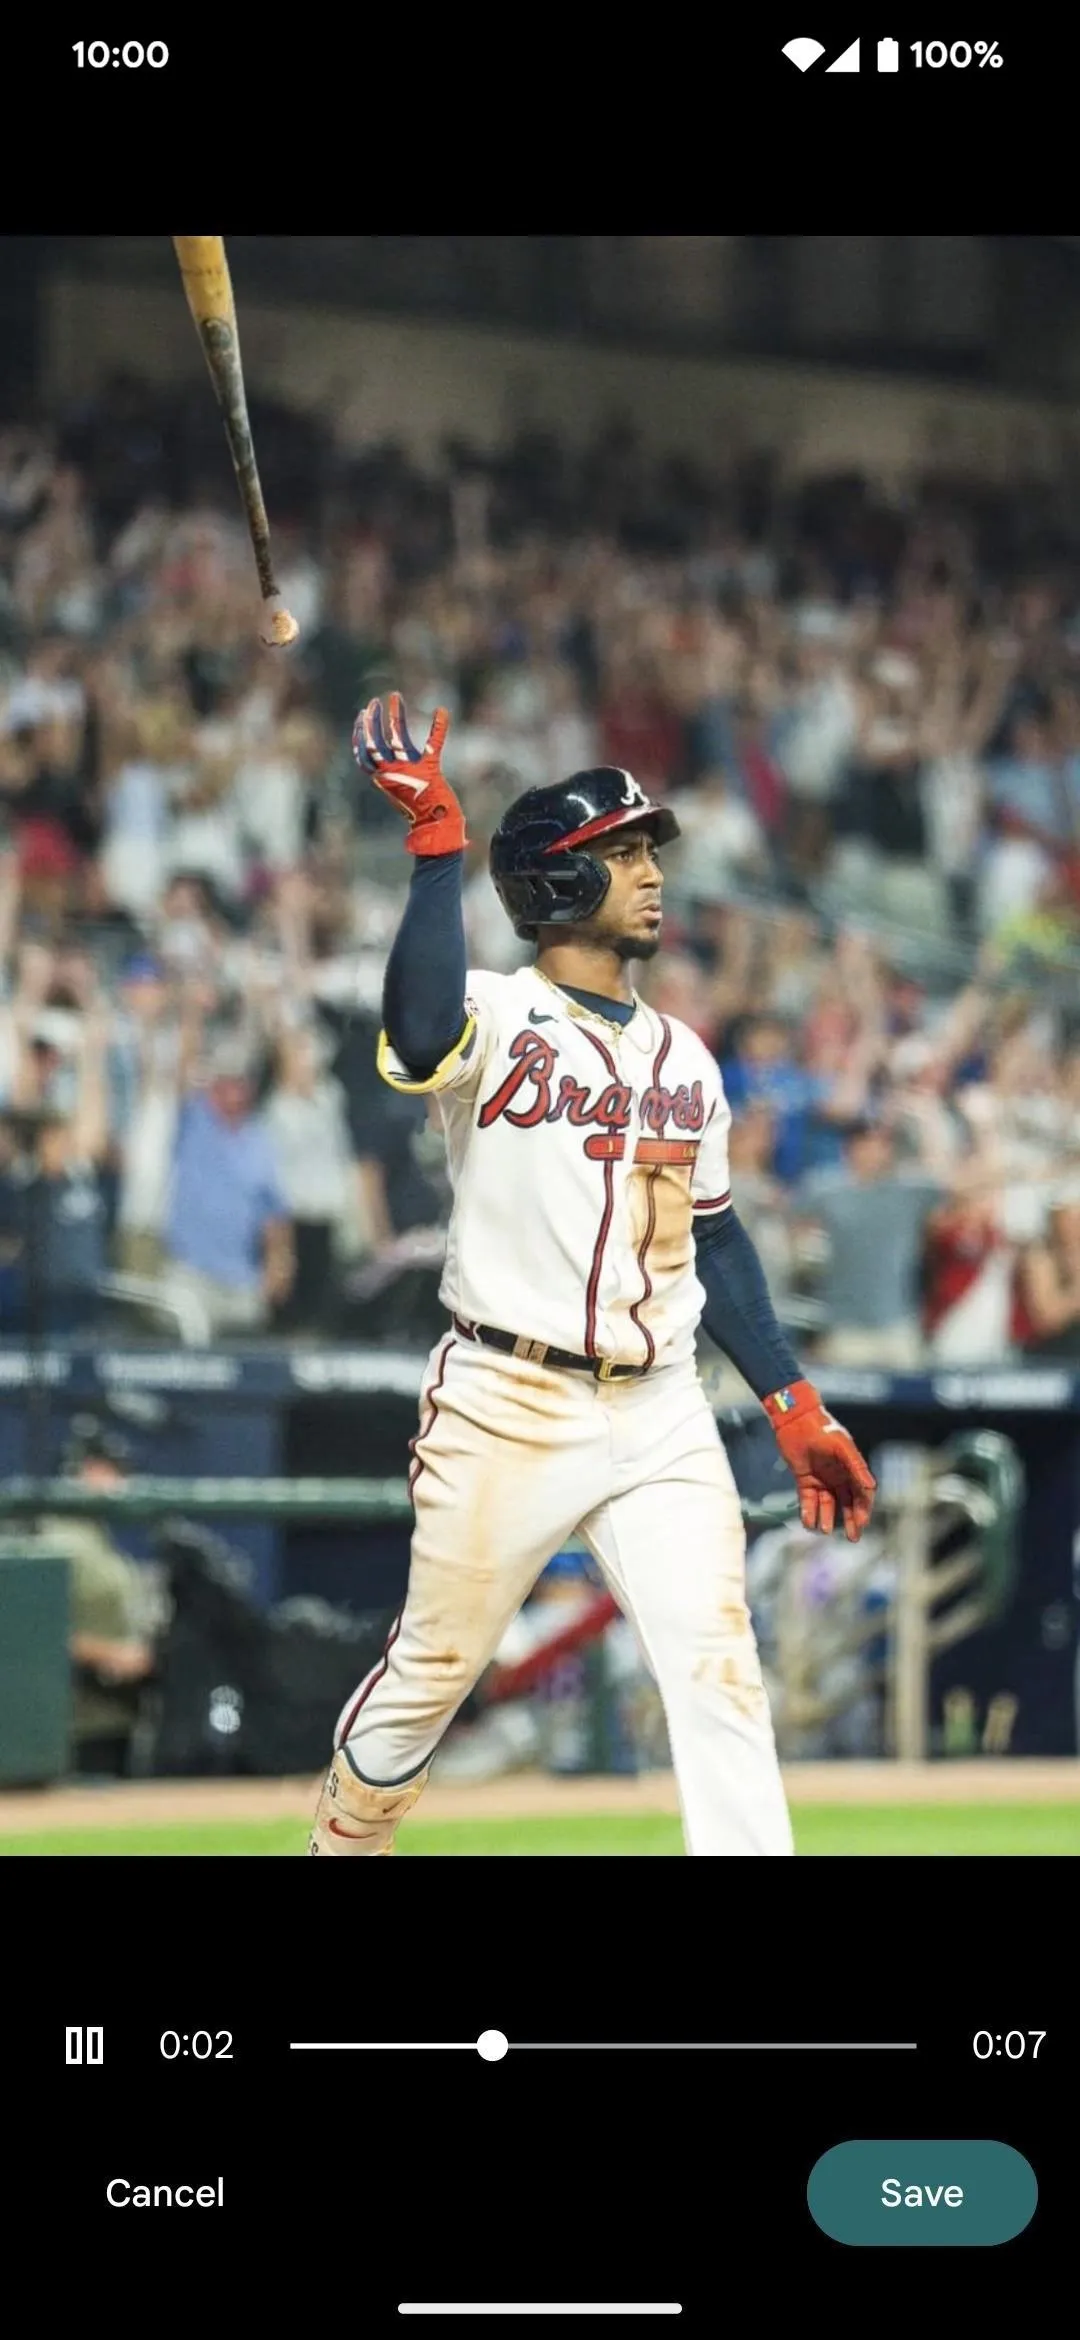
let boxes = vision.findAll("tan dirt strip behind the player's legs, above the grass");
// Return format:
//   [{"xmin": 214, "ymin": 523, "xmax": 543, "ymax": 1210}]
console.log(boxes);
[{"xmin": 0, "ymin": 1757, "xmax": 1080, "ymax": 1837}]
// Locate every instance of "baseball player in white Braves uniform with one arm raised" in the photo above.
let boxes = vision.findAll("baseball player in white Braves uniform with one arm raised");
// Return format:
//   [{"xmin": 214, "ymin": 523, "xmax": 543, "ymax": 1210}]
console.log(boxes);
[{"xmin": 309, "ymin": 693, "xmax": 874, "ymax": 1853}]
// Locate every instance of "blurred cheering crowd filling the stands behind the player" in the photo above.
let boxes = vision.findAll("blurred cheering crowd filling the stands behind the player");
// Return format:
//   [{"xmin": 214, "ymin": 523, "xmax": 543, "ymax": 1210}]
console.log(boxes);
[{"xmin": 0, "ymin": 377, "xmax": 1080, "ymax": 1369}]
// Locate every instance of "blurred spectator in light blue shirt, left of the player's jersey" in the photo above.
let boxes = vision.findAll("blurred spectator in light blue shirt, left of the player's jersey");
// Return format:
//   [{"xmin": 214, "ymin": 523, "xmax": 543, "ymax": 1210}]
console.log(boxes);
[{"xmin": 166, "ymin": 1013, "xmax": 295, "ymax": 1336}]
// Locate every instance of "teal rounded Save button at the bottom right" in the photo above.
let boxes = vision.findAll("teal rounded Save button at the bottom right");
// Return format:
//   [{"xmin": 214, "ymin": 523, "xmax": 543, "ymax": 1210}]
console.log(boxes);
[{"xmin": 806, "ymin": 2136, "xmax": 1038, "ymax": 2249}]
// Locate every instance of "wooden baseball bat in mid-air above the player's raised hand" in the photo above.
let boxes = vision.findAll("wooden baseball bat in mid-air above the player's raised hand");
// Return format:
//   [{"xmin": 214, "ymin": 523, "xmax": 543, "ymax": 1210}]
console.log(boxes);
[{"xmin": 173, "ymin": 236, "xmax": 299, "ymax": 651}]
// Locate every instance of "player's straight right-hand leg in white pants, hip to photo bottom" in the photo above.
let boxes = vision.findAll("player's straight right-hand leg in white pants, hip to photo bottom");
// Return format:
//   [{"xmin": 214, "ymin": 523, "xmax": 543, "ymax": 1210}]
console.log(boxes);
[{"xmin": 580, "ymin": 1369, "xmax": 792, "ymax": 1853}]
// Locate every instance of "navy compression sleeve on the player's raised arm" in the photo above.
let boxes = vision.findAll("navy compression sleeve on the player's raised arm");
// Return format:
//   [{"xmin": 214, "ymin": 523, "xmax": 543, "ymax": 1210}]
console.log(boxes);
[{"xmin": 383, "ymin": 854, "xmax": 465, "ymax": 1081}]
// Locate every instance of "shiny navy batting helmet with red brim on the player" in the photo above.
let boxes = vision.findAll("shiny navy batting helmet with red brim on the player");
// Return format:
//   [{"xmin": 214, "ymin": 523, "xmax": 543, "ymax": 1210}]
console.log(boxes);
[{"xmin": 489, "ymin": 763, "xmax": 678, "ymax": 941}]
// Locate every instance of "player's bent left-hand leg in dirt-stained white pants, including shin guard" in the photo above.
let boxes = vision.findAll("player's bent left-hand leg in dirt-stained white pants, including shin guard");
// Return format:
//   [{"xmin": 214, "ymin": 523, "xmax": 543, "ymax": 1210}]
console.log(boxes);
[{"xmin": 309, "ymin": 1338, "xmax": 610, "ymax": 1853}]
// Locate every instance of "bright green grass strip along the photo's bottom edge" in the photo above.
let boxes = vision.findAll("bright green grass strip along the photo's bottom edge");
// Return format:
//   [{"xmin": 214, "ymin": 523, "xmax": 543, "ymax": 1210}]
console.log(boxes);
[{"xmin": 0, "ymin": 1804, "xmax": 1080, "ymax": 1860}]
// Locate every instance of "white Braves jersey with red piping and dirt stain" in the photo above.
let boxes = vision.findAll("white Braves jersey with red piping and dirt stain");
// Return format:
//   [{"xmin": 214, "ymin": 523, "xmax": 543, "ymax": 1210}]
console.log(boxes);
[{"xmin": 379, "ymin": 966, "xmax": 732, "ymax": 1364}]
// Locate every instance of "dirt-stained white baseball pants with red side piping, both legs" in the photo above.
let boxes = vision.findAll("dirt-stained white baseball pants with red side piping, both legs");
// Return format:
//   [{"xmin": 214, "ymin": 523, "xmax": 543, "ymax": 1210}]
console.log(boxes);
[{"xmin": 334, "ymin": 1334, "xmax": 792, "ymax": 1853}]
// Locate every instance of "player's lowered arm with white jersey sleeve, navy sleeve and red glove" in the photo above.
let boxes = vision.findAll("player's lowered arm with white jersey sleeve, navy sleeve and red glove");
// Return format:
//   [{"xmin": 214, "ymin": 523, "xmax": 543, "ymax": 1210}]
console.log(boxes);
[{"xmin": 692, "ymin": 1088, "xmax": 877, "ymax": 1544}]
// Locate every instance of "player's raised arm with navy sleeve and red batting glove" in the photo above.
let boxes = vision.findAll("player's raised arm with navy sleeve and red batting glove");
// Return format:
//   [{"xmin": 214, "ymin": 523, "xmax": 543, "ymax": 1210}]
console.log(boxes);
[{"xmin": 353, "ymin": 690, "xmax": 470, "ymax": 1090}]
